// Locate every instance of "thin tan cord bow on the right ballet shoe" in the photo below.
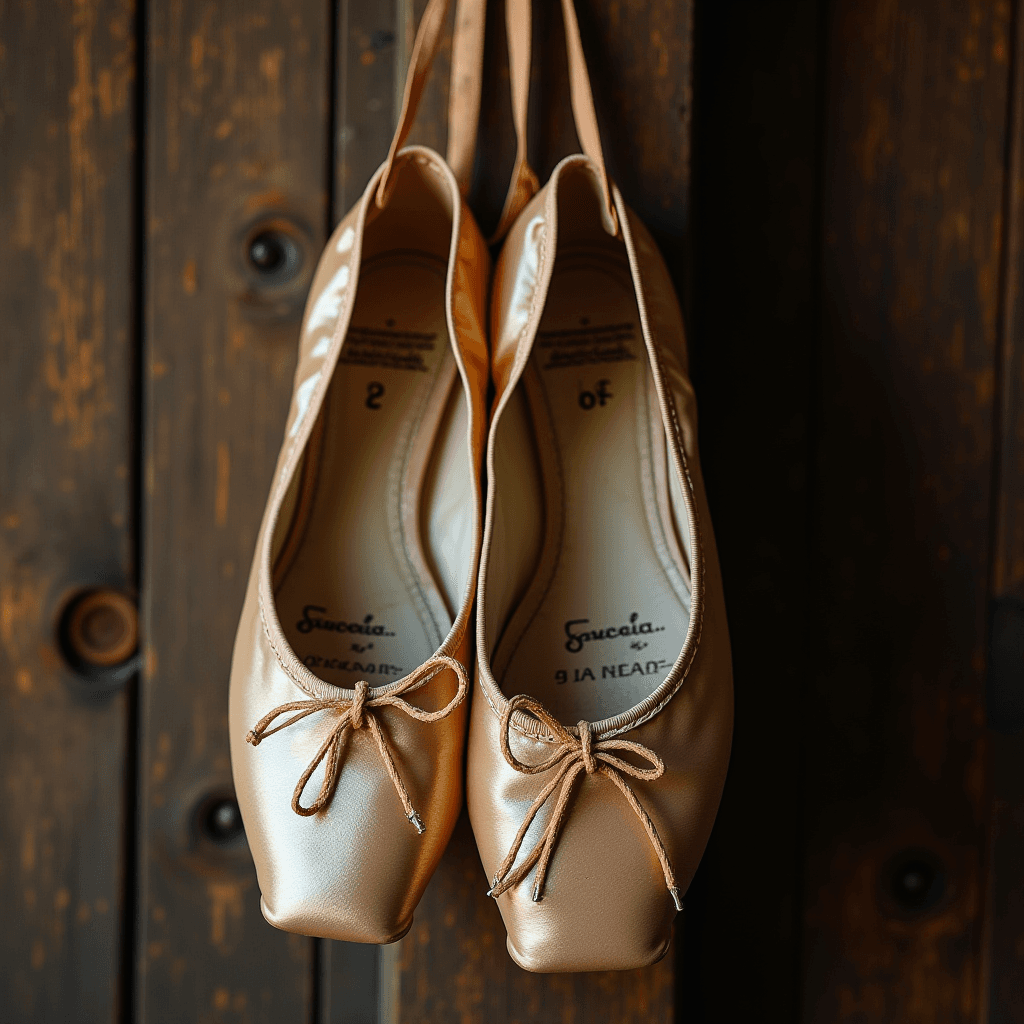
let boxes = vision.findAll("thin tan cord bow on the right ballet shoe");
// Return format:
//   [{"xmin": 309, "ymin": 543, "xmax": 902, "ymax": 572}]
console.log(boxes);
[{"xmin": 487, "ymin": 694, "xmax": 683, "ymax": 910}]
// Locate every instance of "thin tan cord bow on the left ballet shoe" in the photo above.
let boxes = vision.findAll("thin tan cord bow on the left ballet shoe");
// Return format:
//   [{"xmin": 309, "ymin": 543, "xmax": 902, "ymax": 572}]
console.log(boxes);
[{"xmin": 246, "ymin": 654, "xmax": 469, "ymax": 836}]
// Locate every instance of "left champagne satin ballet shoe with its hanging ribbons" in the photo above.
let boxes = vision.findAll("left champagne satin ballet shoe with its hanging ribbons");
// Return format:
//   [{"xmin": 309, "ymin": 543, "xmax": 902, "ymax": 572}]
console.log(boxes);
[{"xmin": 229, "ymin": 0, "xmax": 489, "ymax": 942}]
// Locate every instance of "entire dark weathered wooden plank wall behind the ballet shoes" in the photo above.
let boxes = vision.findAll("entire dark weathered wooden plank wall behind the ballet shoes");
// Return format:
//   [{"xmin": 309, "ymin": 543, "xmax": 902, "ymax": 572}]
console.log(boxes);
[{"xmin": 0, "ymin": 0, "xmax": 1024, "ymax": 1024}]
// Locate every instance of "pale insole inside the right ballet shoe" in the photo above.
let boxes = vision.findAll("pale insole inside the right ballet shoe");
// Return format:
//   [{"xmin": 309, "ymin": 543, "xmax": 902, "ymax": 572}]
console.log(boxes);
[{"xmin": 495, "ymin": 252, "xmax": 690, "ymax": 725}]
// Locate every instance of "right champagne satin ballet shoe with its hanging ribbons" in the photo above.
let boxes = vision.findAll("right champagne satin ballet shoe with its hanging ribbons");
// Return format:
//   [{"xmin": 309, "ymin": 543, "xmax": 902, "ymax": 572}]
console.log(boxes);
[{"xmin": 467, "ymin": 0, "xmax": 732, "ymax": 972}]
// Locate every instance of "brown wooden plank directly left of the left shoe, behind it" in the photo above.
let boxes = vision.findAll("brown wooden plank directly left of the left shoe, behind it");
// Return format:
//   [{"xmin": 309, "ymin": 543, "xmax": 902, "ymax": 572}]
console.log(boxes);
[{"xmin": 136, "ymin": 0, "xmax": 330, "ymax": 1024}]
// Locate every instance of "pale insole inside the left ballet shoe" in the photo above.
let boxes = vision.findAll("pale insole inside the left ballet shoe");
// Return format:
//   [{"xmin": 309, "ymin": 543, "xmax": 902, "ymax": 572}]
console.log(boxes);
[{"xmin": 275, "ymin": 252, "xmax": 457, "ymax": 688}]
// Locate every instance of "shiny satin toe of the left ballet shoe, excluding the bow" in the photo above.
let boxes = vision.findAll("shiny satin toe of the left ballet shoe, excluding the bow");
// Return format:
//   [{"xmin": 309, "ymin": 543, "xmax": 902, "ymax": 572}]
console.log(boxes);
[{"xmin": 229, "ymin": 598, "xmax": 464, "ymax": 943}]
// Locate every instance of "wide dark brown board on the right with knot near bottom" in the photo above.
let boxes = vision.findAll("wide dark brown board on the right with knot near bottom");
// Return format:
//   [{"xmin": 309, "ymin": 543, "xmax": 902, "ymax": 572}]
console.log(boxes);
[{"xmin": 798, "ymin": 0, "xmax": 1010, "ymax": 1024}]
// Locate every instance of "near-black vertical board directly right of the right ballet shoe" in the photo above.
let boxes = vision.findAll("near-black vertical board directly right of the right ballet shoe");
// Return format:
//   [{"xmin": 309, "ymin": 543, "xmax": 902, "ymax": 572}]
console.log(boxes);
[{"xmin": 684, "ymin": 0, "xmax": 821, "ymax": 1024}]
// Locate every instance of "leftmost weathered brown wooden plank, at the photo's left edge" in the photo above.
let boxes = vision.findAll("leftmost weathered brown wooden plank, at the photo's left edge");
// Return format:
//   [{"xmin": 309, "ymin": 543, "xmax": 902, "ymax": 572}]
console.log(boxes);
[{"xmin": 0, "ymin": 0, "xmax": 135, "ymax": 1022}]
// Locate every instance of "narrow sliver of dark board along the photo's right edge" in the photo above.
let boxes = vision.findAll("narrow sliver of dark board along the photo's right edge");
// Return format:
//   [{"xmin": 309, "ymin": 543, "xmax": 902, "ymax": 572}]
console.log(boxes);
[{"xmin": 983, "ymin": 4, "xmax": 1024, "ymax": 1024}]
